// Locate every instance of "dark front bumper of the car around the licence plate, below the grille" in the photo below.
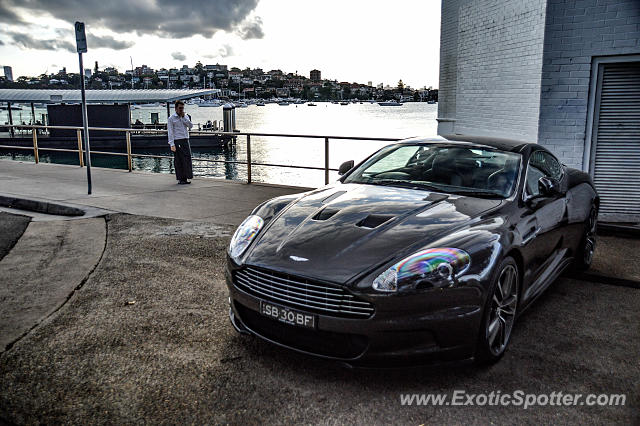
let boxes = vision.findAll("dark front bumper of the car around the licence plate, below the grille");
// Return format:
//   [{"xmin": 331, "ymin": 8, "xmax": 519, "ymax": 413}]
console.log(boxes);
[{"xmin": 226, "ymin": 261, "xmax": 483, "ymax": 366}]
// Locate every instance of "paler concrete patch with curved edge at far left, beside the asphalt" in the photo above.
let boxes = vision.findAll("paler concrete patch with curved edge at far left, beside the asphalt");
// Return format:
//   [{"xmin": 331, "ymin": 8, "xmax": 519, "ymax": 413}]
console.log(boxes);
[{"xmin": 0, "ymin": 218, "xmax": 106, "ymax": 349}]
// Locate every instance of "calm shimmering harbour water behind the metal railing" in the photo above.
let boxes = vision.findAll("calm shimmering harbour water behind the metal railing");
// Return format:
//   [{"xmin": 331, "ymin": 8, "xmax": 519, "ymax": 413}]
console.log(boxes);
[{"xmin": 0, "ymin": 103, "xmax": 438, "ymax": 187}]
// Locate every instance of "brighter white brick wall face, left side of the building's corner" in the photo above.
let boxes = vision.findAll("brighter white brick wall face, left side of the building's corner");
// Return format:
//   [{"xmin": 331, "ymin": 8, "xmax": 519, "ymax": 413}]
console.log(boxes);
[{"xmin": 438, "ymin": 0, "xmax": 546, "ymax": 141}]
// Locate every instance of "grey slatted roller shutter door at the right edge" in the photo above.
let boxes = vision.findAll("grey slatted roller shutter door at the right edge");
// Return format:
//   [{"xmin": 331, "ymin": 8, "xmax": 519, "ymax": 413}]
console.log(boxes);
[{"xmin": 593, "ymin": 62, "xmax": 640, "ymax": 222}]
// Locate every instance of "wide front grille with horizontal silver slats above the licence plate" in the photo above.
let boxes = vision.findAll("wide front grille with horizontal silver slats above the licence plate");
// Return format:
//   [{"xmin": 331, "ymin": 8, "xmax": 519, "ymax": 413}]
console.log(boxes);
[{"xmin": 233, "ymin": 266, "xmax": 374, "ymax": 318}]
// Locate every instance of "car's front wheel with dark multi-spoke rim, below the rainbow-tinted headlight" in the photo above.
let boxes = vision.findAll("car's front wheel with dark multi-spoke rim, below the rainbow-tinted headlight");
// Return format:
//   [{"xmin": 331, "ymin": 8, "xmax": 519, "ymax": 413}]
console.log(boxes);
[{"xmin": 475, "ymin": 257, "xmax": 520, "ymax": 364}]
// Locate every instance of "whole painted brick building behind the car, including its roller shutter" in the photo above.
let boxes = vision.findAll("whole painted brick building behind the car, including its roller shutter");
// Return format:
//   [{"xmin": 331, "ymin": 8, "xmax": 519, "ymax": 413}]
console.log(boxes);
[{"xmin": 438, "ymin": 0, "xmax": 640, "ymax": 222}]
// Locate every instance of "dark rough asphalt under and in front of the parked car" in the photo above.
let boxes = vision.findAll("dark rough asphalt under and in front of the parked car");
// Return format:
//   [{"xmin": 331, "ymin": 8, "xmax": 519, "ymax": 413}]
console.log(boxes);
[{"xmin": 0, "ymin": 215, "xmax": 640, "ymax": 424}]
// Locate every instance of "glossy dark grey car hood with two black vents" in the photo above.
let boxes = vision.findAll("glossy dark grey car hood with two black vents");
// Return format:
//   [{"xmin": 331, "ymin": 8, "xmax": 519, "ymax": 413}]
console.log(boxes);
[{"xmin": 245, "ymin": 184, "xmax": 501, "ymax": 283}]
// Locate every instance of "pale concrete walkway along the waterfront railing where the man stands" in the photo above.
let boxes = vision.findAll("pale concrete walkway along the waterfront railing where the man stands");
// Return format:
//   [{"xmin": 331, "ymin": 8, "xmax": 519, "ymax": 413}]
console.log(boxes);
[{"xmin": 0, "ymin": 160, "xmax": 309, "ymax": 225}]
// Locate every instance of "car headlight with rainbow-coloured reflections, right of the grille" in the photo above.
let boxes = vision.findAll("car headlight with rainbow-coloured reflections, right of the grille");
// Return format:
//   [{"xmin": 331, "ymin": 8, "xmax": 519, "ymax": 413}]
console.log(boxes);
[{"xmin": 372, "ymin": 248, "xmax": 471, "ymax": 292}]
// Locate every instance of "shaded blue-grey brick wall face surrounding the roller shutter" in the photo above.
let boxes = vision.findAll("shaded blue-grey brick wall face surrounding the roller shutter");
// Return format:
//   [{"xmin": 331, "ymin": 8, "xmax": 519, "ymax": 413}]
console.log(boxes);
[{"xmin": 538, "ymin": 0, "xmax": 640, "ymax": 170}]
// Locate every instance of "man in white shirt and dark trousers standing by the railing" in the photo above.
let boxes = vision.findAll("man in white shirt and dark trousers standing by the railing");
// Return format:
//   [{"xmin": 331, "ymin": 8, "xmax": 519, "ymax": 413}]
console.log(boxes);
[{"xmin": 167, "ymin": 101, "xmax": 193, "ymax": 185}]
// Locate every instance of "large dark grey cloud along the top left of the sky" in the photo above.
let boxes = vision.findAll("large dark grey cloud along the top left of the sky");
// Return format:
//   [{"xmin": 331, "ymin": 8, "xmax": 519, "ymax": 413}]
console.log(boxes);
[{"xmin": 0, "ymin": 0, "xmax": 263, "ymax": 39}]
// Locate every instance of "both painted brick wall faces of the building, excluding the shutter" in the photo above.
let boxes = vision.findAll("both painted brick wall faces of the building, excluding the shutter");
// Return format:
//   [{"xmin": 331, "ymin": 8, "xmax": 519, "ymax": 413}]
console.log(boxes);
[{"xmin": 438, "ymin": 0, "xmax": 640, "ymax": 169}]
